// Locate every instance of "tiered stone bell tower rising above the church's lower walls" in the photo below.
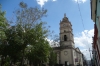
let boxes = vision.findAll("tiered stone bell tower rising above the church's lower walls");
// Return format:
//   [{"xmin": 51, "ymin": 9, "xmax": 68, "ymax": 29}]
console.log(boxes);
[{"xmin": 60, "ymin": 14, "xmax": 75, "ymax": 48}]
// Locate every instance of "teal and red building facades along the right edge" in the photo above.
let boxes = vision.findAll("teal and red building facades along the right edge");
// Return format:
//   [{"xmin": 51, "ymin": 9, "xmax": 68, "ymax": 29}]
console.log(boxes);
[{"xmin": 91, "ymin": 0, "xmax": 100, "ymax": 66}]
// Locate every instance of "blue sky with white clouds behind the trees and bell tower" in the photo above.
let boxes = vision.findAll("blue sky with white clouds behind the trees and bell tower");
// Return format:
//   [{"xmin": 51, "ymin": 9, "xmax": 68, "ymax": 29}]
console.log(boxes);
[{"xmin": 0, "ymin": 0, "xmax": 94, "ymax": 59}]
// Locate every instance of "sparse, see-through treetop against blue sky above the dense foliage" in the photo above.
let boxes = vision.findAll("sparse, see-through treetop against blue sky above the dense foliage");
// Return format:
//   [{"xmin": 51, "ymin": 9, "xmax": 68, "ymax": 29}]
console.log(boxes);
[{"xmin": 15, "ymin": 2, "xmax": 47, "ymax": 31}]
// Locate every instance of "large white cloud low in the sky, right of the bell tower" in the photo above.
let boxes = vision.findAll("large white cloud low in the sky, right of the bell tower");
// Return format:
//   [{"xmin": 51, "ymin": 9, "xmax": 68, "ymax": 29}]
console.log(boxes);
[{"xmin": 74, "ymin": 29, "xmax": 94, "ymax": 59}]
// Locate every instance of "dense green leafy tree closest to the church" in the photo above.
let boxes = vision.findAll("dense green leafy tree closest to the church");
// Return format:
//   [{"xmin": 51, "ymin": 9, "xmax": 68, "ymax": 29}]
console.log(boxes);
[{"xmin": 26, "ymin": 22, "xmax": 50, "ymax": 66}]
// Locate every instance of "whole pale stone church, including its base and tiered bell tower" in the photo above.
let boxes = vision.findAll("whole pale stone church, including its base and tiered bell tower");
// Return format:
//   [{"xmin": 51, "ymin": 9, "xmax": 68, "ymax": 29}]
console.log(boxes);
[{"xmin": 54, "ymin": 14, "xmax": 83, "ymax": 66}]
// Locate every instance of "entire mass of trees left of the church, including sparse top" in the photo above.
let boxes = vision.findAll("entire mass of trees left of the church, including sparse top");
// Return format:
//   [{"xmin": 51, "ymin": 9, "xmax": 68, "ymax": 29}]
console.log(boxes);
[{"xmin": 0, "ymin": 3, "xmax": 55, "ymax": 66}]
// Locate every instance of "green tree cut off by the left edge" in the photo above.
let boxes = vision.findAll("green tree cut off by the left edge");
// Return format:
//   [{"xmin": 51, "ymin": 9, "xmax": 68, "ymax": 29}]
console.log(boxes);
[{"xmin": 0, "ymin": 5, "xmax": 8, "ymax": 66}]
